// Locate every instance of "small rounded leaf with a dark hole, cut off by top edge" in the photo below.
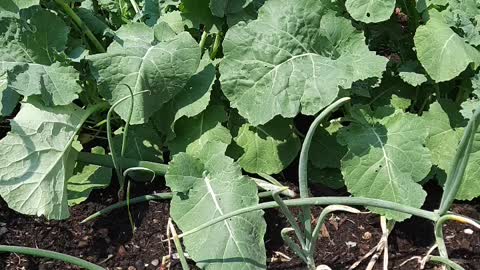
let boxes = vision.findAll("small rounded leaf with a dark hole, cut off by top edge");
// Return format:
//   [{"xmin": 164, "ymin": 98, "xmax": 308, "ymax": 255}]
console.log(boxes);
[{"xmin": 345, "ymin": 0, "xmax": 396, "ymax": 23}]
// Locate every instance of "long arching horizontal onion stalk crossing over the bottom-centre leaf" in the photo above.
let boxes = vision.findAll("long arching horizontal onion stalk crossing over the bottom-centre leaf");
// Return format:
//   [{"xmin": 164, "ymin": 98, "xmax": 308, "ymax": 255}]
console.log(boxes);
[{"xmin": 181, "ymin": 197, "xmax": 440, "ymax": 237}]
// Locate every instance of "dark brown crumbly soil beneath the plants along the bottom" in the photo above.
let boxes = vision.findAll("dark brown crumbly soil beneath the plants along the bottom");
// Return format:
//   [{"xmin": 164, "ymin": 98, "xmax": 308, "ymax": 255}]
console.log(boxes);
[{"xmin": 0, "ymin": 179, "xmax": 480, "ymax": 270}]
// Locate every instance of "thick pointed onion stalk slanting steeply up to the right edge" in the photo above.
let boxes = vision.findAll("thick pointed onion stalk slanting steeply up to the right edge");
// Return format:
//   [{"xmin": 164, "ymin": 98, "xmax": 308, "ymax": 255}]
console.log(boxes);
[{"xmin": 438, "ymin": 108, "xmax": 480, "ymax": 216}]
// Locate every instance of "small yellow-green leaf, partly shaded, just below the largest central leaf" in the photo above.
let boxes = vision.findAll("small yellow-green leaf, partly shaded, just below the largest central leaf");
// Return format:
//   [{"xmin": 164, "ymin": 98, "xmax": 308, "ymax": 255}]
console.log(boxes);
[{"xmin": 235, "ymin": 118, "xmax": 300, "ymax": 175}]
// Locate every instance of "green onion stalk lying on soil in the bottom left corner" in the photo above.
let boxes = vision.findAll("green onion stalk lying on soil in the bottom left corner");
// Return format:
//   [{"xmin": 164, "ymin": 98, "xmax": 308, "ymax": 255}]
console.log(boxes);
[{"xmin": 0, "ymin": 245, "xmax": 105, "ymax": 270}]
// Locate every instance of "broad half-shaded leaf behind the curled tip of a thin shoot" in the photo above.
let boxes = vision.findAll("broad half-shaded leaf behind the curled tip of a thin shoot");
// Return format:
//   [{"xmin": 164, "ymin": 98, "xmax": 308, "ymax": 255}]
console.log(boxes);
[{"xmin": 89, "ymin": 24, "xmax": 200, "ymax": 124}]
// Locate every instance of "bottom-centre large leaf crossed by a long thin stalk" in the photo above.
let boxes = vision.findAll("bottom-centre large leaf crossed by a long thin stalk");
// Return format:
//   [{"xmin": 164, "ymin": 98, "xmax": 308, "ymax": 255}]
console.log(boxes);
[{"xmin": 165, "ymin": 141, "xmax": 266, "ymax": 270}]
